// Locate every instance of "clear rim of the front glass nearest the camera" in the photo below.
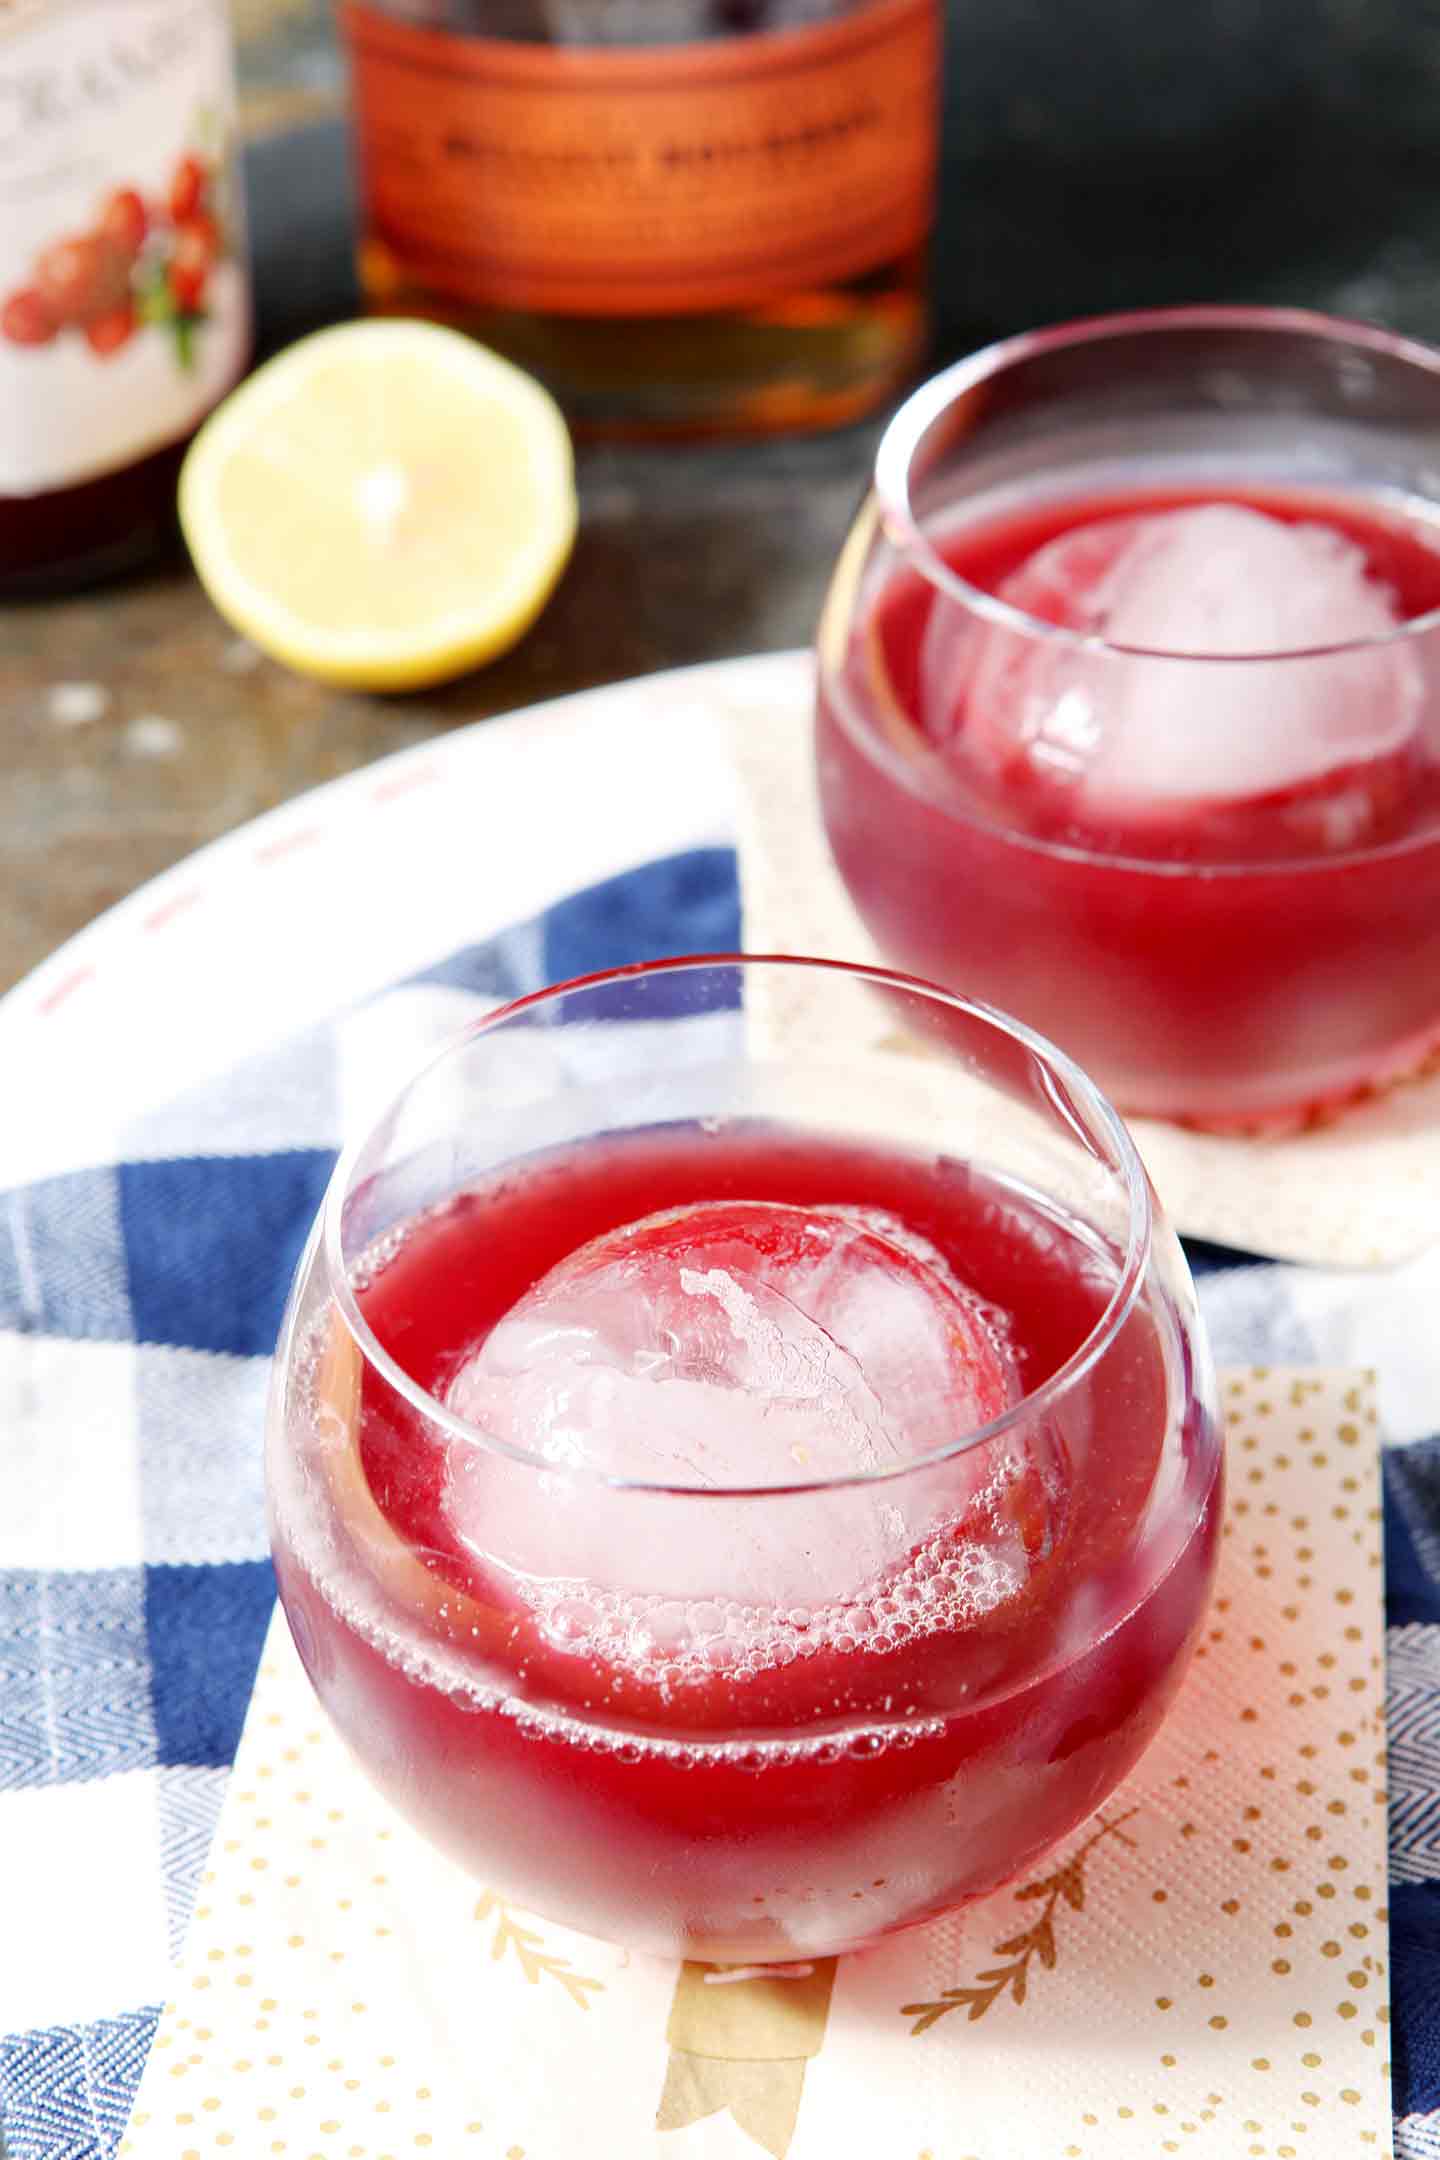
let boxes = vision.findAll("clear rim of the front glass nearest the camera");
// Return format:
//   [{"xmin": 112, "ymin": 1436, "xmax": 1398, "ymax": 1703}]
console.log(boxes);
[{"xmin": 315, "ymin": 953, "xmax": 1155, "ymax": 1501}]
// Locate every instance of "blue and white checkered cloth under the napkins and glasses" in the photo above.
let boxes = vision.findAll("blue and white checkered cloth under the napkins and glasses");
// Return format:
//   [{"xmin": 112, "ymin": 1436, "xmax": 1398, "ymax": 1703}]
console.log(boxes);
[{"xmin": 0, "ymin": 849, "xmax": 1440, "ymax": 2160}]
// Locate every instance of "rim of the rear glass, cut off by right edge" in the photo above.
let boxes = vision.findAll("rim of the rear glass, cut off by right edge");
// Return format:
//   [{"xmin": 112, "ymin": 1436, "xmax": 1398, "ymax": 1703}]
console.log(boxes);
[{"xmin": 872, "ymin": 305, "xmax": 1440, "ymax": 667}]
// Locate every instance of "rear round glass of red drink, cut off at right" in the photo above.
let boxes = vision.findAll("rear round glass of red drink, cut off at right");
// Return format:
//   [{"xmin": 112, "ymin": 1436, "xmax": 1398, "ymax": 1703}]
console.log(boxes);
[{"xmin": 818, "ymin": 309, "xmax": 1440, "ymax": 1128}]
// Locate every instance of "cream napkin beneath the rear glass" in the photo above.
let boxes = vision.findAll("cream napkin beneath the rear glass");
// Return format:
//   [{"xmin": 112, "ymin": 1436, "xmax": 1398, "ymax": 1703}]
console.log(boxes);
[{"xmin": 721, "ymin": 654, "xmax": 1440, "ymax": 1268}]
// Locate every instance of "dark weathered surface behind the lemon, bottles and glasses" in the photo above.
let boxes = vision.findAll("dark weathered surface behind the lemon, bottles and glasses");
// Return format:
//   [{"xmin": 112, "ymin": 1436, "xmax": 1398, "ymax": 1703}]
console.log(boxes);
[{"xmin": 0, "ymin": 0, "xmax": 1440, "ymax": 987}]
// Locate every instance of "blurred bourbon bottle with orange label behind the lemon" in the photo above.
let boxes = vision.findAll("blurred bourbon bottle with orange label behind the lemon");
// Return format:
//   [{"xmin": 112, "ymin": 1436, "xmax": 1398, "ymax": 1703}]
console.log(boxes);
[{"xmin": 341, "ymin": 0, "xmax": 941, "ymax": 434}]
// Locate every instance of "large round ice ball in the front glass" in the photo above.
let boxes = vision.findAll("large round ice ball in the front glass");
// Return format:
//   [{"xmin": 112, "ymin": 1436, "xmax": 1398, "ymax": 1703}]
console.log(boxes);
[{"xmin": 445, "ymin": 1201, "xmax": 1058, "ymax": 1650}]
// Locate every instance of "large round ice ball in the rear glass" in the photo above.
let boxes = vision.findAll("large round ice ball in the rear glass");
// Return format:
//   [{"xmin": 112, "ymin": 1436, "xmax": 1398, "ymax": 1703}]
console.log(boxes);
[{"xmin": 920, "ymin": 503, "xmax": 1425, "ymax": 851}]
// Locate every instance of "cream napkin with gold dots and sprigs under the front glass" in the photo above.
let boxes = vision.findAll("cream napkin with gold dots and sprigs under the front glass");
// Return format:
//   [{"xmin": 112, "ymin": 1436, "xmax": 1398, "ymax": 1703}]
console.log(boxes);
[{"xmin": 121, "ymin": 1369, "xmax": 1390, "ymax": 2160}]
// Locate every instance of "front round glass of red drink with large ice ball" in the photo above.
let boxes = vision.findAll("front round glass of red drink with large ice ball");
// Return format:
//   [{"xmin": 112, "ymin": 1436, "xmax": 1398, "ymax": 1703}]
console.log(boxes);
[{"xmin": 268, "ymin": 959, "xmax": 1220, "ymax": 1961}]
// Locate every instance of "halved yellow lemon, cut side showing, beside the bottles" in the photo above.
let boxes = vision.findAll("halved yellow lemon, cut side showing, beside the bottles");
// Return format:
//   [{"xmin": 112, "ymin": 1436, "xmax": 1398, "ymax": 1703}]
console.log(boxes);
[{"xmin": 179, "ymin": 320, "xmax": 576, "ymax": 689}]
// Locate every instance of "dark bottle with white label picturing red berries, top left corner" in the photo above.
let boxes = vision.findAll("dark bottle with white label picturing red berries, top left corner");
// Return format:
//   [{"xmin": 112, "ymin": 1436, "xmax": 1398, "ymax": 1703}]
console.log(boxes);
[{"xmin": 0, "ymin": 0, "xmax": 250, "ymax": 594}]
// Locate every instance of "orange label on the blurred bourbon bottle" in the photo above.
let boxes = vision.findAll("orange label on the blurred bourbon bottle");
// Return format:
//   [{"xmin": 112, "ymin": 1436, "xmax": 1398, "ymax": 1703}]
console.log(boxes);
[{"xmin": 343, "ymin": 0, "xmax": 939, "ymax": 315}]
